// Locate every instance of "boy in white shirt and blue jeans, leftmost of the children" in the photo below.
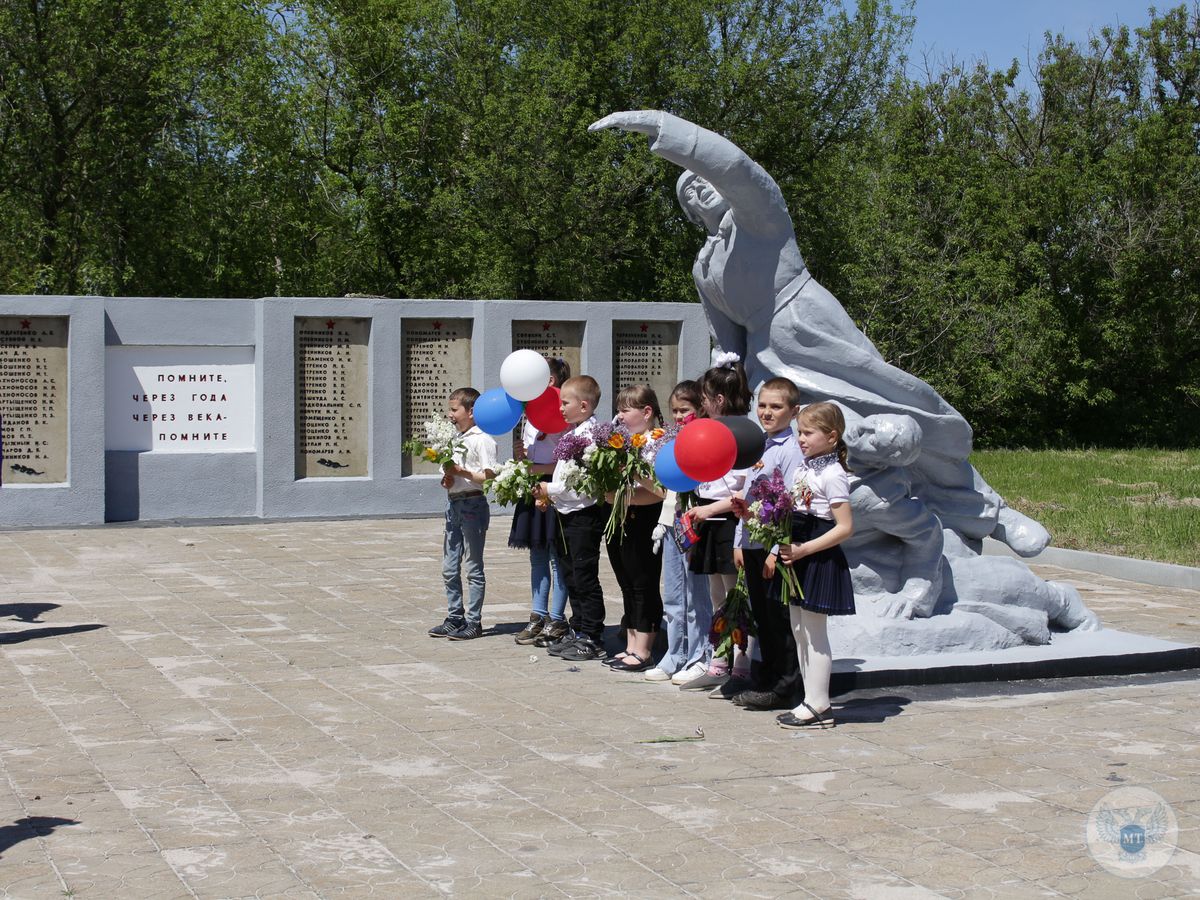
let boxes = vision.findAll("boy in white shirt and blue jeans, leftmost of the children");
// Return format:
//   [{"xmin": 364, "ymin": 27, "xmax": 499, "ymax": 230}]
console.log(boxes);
[{"xmin": 428, "ymin": 388, "xmax": 497, "ymax": 641}]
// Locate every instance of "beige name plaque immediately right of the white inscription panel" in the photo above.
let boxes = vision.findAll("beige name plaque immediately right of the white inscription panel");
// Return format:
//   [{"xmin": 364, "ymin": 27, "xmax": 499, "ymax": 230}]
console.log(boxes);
[{"xmin": 295, "ymin": 316, "xmax": 371, "ymax": 479}]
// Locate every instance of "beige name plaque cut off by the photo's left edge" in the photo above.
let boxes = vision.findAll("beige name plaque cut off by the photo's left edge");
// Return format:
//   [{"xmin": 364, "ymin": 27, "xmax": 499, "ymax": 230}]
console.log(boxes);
[{"xmin": 0, "ymin": 316, "xmax": 70, "ymax": 485}]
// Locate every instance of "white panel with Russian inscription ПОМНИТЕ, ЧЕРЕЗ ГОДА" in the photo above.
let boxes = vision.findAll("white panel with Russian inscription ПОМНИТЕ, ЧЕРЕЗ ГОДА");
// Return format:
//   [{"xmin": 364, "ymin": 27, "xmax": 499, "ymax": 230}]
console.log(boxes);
[{"xmin": 104, "ymin": 347, "xmax": 254, "ymax": 454}]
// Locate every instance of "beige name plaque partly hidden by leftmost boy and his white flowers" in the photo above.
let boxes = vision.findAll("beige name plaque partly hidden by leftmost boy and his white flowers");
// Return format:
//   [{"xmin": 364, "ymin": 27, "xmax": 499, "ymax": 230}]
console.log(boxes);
[{"xmin": 400, "ymin": 319, "xmax": 478, "ymax": 475}]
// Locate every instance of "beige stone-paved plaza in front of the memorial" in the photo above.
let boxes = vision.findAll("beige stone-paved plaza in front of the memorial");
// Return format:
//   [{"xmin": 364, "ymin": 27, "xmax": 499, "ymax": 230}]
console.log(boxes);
[{"xmin": 0, "ymin": 518, "xmax": 1200, "ymax": 900}]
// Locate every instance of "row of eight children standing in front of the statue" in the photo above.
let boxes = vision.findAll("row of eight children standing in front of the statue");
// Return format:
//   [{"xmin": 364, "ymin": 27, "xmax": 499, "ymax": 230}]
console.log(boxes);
[{"xmin": 428, "ymin": 354, "xmax": 854, "ymax": 728}]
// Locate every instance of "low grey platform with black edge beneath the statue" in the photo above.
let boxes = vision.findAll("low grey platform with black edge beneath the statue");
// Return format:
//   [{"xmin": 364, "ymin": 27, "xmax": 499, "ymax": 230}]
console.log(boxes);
[{"xmin": 830, "ymin": 629, "xmax": 1200, "ymax": 694}]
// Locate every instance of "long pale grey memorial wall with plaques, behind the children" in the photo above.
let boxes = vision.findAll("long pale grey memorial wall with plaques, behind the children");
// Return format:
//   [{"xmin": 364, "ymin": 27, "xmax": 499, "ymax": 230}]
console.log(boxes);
[{"xmin": 0, "ymin": 295, "xmax": 709, "ymax": 527}]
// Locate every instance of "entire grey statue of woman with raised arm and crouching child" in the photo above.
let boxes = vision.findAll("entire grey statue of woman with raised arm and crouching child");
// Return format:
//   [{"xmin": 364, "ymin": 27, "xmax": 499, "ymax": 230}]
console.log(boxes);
[{"xmin": 589, "ymin": 110, "xmax": 1099, "ymax": 656}]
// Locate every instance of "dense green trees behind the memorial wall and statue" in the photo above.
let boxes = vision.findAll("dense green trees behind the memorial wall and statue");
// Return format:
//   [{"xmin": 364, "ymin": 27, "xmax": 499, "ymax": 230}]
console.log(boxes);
[{"xmin": 0, "ymin": 0, "xmax": 1200, "ymax": 444}]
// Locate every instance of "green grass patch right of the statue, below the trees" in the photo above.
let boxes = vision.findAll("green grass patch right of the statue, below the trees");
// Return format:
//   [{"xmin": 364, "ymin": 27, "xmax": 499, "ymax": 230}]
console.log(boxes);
[{"xmin": 971, "ymin": 450, "xmax": 1200, "ymax": 566}]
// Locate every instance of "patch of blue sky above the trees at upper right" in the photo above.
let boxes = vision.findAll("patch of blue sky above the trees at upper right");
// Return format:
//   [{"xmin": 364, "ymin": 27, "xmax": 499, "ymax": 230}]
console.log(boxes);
[{"xmin": 912, "ymin": 0, "xmax": 1156, "ymax": 76}]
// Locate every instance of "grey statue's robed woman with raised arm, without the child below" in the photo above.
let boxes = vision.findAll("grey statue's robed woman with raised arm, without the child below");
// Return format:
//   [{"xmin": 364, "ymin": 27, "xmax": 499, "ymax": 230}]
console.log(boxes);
[{"xmin": 589, "ymin": 110, "xmax": 1049, "ymax": 556}]
